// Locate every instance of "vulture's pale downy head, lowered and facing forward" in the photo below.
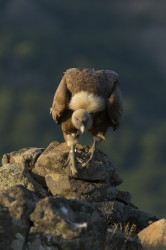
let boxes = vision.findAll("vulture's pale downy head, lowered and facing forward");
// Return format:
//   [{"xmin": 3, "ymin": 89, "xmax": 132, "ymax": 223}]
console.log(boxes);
[{"xmin": 71, "ymin": 109, "xmax": 92, "ymax": 133}]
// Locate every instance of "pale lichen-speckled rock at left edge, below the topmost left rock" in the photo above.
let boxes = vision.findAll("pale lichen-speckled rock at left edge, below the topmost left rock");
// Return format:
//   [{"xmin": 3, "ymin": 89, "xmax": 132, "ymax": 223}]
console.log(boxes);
[{"xmin": 0, "ymin": 162, "xmax": 47, "ymax": 196}]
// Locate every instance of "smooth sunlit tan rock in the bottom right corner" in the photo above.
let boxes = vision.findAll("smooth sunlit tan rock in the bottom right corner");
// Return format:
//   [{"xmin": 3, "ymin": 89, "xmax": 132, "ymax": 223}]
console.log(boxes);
[{"xmin": 138, "ymin": 219, "xmax": 166, "ymax": 250}]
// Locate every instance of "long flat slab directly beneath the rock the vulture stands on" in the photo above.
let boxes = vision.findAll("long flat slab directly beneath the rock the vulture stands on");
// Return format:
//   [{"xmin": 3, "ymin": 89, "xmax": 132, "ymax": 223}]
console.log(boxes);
[{"xmin": 45, "ymin": 174, "xmax": 131, "ymax": 203}]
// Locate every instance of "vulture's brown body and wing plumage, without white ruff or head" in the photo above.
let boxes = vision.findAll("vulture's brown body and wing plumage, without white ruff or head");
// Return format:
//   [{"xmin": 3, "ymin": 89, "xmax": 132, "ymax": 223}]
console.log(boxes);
[{"xmin": 52, "ymin": 68, "xmax": 123, "ymax": 146}]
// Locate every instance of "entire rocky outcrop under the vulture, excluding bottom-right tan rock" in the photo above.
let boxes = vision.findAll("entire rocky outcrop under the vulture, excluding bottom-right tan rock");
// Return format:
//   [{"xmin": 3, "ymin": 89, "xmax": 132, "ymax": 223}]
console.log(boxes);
[{"xmin": 0, "ymin": 142, "xmax": 160, "ymax": 250}]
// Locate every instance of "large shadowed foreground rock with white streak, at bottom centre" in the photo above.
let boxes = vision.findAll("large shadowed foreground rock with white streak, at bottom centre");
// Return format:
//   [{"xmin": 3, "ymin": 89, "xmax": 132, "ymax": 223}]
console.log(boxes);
[{"xmin": 27, "ymin": 197, "xmax": 106, "ymax": 250}]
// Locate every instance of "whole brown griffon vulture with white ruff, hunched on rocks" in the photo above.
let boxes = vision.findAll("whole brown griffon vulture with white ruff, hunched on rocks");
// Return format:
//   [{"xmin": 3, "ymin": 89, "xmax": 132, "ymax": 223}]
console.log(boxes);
[{"xmin": 51, "ymin": 68, "xmax": 123, "ymax": 175}]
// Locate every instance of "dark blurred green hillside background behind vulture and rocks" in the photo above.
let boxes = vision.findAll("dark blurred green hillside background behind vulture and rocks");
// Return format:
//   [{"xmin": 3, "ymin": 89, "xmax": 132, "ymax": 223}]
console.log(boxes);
[{"xmin": 0, "ymin": 0, "xmax": 166, "ymax": 217}]
